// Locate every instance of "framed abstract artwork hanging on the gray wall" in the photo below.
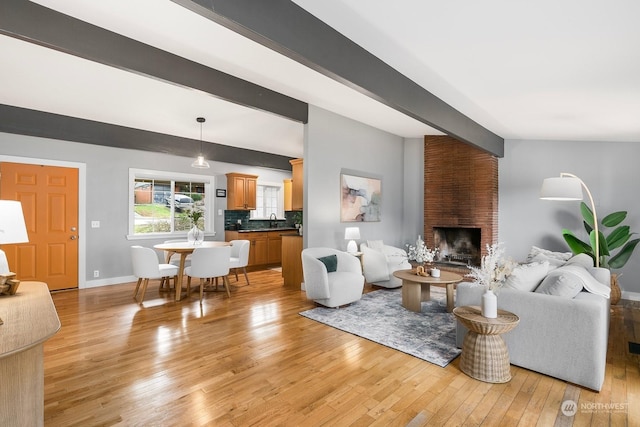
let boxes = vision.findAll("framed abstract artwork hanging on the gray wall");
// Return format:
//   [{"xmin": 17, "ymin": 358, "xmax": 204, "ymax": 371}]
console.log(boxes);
[{"xmin": 340, "ymin": 173, "xmax": 382, "ymax": 222}]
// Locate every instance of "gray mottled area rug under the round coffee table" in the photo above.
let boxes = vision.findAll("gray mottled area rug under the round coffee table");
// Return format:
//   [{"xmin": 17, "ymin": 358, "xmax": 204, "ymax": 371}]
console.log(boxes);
[{"xmin": 300, "ymin": 288, "xmax": 460, "ymax": 367}]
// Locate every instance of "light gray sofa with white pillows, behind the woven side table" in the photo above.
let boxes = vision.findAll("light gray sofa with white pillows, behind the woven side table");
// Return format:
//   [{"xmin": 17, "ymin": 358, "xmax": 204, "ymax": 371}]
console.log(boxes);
[{"xmin": 456, "ymin": 251, "xmax": 610, "ymax": 391}]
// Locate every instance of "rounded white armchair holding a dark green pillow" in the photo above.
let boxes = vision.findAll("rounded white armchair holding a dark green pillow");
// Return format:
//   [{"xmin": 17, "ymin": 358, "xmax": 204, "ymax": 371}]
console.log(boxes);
[{"xmin": 302, "ymin": 248, "xmax": 364, "ymax": 307}]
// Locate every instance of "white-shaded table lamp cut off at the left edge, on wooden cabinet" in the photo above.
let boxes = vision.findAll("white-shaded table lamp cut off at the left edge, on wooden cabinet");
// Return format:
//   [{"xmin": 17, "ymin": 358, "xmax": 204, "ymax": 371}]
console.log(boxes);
[{"xmin": 0, "ymin": 200, "xmax": 29, "ymax": 295}]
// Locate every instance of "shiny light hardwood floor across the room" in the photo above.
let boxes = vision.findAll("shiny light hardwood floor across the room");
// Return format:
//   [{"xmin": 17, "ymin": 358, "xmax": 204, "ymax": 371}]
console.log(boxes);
[{"xmin": 45, "ymin": 270, "xmax": 640, "ymax": 427}]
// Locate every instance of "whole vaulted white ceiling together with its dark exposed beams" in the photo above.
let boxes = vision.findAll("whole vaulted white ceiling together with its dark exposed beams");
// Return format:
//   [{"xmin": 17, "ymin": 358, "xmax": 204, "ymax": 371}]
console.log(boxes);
[{"xmin": 0, "ymin": 0, "xmax": 640, "ymax": 164}]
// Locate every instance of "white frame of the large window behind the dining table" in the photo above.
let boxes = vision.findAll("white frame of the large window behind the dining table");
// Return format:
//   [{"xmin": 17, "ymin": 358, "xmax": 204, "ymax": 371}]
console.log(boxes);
[{"xmin": 127, "ymin": 168, "xmax": 216, "ymax": 240}]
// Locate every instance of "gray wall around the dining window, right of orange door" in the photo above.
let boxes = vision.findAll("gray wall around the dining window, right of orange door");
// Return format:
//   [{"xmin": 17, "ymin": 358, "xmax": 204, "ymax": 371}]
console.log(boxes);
[{"xmin": 0, "ymin": 133, "xmax": 291, "ymax": 287}]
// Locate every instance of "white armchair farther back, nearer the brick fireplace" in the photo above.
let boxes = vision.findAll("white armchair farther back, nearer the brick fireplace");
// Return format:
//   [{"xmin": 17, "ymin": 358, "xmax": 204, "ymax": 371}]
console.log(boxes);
[{"xmin": 360, "ymin": 242, "xmax": 411, "ymax": 288}]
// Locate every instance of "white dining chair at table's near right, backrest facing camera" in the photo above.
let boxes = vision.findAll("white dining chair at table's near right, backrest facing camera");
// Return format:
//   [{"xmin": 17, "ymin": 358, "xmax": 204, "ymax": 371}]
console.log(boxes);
[{"xmin": 184, "ymin": 246, "xmax": 231, "ymax": 304}]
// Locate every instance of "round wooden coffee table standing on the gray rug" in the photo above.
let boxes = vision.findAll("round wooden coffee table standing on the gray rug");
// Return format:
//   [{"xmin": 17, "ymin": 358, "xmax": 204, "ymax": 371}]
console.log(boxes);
[{"xmin": 393, "ymin": 269, "xmax": 462, "ymax": 313}]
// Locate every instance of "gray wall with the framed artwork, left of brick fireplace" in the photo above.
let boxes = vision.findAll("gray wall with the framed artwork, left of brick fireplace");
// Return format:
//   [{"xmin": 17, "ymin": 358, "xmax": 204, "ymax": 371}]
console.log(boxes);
[{"xmin": 304, "ymin": 106, "xmax": 423, "ymax": 250}]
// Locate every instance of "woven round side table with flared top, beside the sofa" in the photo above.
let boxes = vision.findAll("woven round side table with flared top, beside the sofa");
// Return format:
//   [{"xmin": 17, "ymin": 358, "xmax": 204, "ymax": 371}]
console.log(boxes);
[{"xmin": 453, "ymin": 306, "xmax": 520, "ymax": 383}]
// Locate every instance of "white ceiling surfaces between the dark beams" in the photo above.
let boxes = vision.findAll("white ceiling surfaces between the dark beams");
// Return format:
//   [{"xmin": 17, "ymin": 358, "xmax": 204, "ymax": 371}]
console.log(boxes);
[{"xmin": 5, "ymin": 0, "xmax": 640, "ymax": 157}]
